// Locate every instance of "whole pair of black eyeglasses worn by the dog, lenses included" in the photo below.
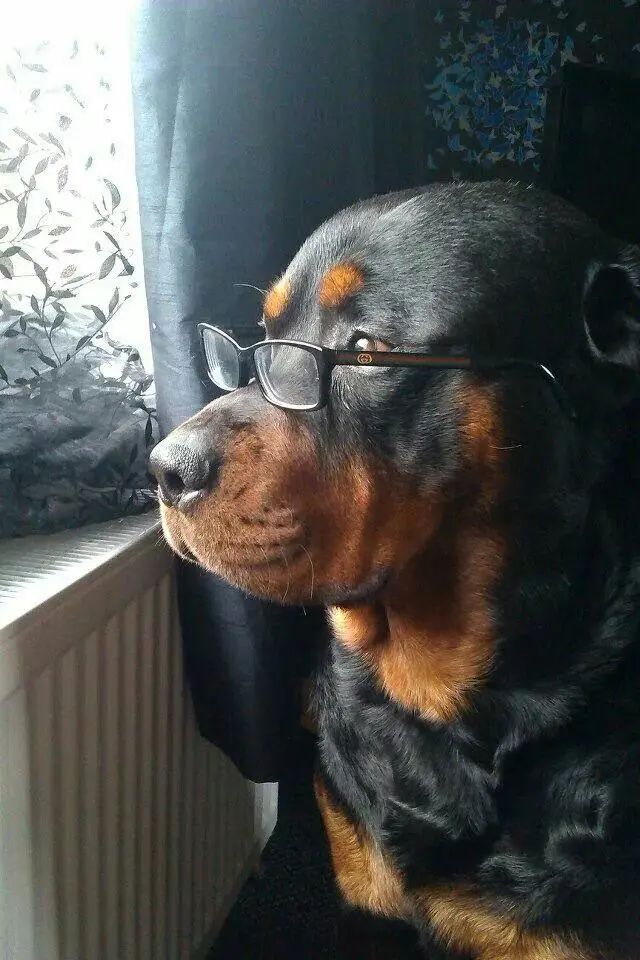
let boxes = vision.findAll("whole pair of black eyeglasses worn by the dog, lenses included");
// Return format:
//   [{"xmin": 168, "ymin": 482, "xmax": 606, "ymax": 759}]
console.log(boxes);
[{"xmin": 198, "ymin": 323, "xmax": 576, "ymax": 420}]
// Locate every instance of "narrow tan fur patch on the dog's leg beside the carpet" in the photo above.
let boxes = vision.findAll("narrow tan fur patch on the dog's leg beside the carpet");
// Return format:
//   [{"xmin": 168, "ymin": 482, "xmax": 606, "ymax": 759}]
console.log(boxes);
[{"xmin": 314, "ymin": 777, "xmax": 407, "ymax": 917}]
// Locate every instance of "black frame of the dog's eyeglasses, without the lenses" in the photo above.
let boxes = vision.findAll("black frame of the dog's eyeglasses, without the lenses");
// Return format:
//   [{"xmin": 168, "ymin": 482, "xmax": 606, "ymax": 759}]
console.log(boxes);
[{"xmin": 197, "ymin": 323, "xmax": 577, "ymax": 420}]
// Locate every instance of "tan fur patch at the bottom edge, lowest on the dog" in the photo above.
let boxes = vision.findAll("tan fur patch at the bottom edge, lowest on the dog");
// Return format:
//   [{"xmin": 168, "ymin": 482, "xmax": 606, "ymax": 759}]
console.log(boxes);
[{"xmin": 416, "ymin": 888, "xmax": 592, "ymax": 960}]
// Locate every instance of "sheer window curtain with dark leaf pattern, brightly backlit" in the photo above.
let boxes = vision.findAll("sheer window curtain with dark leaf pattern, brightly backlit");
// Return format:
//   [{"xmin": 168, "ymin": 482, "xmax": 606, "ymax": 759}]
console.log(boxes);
[{"xmin": 0, "ymin": 5, "xmax": 155, "ymax": 537}]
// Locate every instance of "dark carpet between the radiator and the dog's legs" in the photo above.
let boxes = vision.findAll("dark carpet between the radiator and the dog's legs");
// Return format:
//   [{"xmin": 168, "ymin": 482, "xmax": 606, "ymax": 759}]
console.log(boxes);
[{"xmin": 209, "ymin": 734, "xmax": 424, "ymax": 960}]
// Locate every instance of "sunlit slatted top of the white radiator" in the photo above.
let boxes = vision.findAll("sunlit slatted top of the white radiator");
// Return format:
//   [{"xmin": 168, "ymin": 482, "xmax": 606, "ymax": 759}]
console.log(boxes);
[{"xmin": 0, "ymin": 510, "xmax": 171, "ymax": 643}]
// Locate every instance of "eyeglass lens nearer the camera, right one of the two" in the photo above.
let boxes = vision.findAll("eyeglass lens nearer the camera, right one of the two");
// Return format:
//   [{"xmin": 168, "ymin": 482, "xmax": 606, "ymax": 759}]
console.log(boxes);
[{"xmin": 254, "ymin": 342, "xmax": 320, "ymax": 410}]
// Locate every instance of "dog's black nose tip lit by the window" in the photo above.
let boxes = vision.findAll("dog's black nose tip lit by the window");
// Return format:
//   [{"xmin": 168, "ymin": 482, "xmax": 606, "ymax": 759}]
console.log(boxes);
[{"xmin": 149, "ymin": 436, "xmax": 213, "ymax": 508}]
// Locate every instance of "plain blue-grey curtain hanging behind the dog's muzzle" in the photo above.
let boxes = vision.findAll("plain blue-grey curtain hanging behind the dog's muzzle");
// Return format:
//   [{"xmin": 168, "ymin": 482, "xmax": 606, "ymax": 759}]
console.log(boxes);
[{"xmin": 133, "ymin": 0, "xmax": 375, "ymax": 781}]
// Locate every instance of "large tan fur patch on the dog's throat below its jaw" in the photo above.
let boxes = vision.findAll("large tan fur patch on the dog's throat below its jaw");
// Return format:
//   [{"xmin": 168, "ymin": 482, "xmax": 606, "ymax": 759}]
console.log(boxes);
[{"xmin": 330, "ymin": 512, "xmax": 504, "ymax": 721}]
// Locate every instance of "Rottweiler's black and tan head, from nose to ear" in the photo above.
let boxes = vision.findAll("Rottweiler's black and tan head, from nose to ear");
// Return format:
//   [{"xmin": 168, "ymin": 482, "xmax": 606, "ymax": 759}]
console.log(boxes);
[{"xmin": 152, "ymin": 183, "xmax": 640, "ymax": 604}]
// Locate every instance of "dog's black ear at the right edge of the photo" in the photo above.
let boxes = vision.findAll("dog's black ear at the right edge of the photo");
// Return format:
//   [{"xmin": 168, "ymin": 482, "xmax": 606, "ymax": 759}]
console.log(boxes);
[{"xmin": 583, "ymin": 247, "xmax": 640, "ymax": 373}]
